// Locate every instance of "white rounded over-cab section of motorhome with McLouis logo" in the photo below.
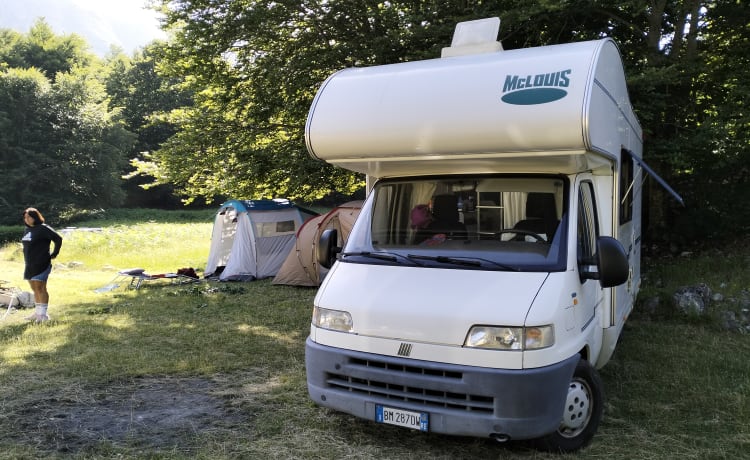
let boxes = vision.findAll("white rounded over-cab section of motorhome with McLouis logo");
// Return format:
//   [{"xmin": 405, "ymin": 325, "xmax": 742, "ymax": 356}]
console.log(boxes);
[{"xmin": 305, "ymin": 39, "xmax": 641, "ymax": 178}]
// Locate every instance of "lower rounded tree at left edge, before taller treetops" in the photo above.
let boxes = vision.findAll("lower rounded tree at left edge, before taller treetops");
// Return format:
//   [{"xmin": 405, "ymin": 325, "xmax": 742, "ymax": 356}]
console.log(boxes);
[{"xmin": 0, "ymin": 69, "xmax": 132, "ymax": 221}]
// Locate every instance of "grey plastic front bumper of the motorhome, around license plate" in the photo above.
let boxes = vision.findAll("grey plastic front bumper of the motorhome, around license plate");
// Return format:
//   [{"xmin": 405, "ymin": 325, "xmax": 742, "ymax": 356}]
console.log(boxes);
[{"xmin": 305, "ymin": 337, "xmax": 579, "ymax": 439}]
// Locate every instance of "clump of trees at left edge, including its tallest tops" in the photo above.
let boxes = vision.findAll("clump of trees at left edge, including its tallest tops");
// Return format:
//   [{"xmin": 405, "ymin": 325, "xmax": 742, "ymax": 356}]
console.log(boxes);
[{"xmin": 0, "ymin": 22, "xmax": 133, "ymax": 223}]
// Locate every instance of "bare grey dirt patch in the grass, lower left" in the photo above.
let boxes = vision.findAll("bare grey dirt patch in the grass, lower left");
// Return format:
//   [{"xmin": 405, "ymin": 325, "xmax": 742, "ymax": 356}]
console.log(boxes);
[{"xmin": 9, "ymin": 378, "xmax": 243, "ymax": 452}]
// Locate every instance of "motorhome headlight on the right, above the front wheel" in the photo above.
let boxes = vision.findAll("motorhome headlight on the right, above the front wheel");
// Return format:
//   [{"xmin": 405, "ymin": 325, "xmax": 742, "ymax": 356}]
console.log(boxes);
[{"xmin": 464, "ymin": 326, "xmax": 555, "ymax": 350}]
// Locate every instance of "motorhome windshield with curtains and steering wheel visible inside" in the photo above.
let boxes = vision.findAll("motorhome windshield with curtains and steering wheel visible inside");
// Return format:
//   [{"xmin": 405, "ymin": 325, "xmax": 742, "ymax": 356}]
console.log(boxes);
[{"xmin": 341, "ymin": 175, "xmax": 568, "ymax": 271}]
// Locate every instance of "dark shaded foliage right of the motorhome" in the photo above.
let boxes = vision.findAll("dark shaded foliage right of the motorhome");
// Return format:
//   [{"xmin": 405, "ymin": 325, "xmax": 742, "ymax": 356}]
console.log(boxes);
[{"xmin": 626, "ymin": 1, "xmax": 750, "ymax": 243}]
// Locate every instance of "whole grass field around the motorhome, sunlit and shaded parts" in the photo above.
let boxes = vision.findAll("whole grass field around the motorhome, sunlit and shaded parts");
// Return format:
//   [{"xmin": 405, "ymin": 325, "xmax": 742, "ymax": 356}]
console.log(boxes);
[{"xmin": 0, "ymin": 212, "xmax": 750, "ymax": 459}]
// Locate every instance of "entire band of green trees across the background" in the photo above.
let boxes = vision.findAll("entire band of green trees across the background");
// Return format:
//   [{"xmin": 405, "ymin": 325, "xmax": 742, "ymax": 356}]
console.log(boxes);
[{"xmin": 0, "ymin": 0, "xmax": 750, "ymax": 243}]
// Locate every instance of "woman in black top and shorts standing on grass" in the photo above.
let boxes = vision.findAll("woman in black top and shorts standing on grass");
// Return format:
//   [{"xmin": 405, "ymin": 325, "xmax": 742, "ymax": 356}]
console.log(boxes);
[{"xmin": 21, "ymin": 208, "xmax": 62, "ymax": 323}]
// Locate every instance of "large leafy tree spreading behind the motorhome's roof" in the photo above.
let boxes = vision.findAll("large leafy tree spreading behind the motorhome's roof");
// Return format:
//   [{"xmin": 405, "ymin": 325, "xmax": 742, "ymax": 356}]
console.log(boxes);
[{"xmin": 144, "ymin": 0, "xmax": 750, "ymax": 236}]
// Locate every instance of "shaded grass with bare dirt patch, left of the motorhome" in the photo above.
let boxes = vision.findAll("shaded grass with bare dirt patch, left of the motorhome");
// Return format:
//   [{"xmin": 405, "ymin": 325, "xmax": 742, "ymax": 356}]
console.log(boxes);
[{"xmin": 0, "ymin": 281, "xmax": 564, "ymax": 458}]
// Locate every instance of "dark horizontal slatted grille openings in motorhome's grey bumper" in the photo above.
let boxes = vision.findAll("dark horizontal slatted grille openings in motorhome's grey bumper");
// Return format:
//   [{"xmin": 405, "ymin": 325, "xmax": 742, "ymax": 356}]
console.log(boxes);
[{"xmin": 326, "ymin": 358, "xmax": 494, "ymax": 413}]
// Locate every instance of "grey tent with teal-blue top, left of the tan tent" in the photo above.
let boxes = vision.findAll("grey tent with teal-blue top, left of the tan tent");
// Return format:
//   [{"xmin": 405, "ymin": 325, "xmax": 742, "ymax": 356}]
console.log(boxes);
[{"xmin": 204, "ymin": 199, "xmax": 317, "ymax": 281}]
